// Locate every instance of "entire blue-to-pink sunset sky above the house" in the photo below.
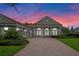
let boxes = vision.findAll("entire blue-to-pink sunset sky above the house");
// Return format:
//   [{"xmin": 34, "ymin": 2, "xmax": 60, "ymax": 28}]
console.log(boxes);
[{"xmin": 0, "ymin": 3, "xmax": 79, "ymax": 27}]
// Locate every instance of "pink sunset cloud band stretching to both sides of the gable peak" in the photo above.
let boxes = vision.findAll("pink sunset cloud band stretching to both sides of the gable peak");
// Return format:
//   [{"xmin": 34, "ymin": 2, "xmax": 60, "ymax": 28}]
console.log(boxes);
[{"xmin": 10, "ymin": 14, "xmax": 79, "ymax": 27}]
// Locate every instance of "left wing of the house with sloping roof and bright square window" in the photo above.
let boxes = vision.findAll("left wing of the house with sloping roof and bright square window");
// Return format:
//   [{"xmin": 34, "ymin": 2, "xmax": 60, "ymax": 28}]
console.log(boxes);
[{"xmin": 0, "ymin": 14, "xmax": 26, "ymax": 36}]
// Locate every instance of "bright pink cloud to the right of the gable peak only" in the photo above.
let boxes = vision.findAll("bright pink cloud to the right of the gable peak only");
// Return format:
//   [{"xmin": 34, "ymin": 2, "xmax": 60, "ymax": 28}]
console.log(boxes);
[{"xmin": 54, "ymin": 15, "xmax": 79, "ymax": 27}]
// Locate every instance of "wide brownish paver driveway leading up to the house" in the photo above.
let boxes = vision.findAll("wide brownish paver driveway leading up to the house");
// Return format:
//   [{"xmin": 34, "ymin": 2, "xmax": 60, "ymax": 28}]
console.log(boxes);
[{"xmin": 15, "ymin": 38, "xmax": 79, "ymax": 56}]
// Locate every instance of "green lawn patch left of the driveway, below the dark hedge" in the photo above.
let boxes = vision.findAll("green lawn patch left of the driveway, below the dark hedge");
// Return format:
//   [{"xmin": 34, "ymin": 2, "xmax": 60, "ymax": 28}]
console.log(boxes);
[{"xmin": 0, "ymin": 45, "xmax": 25, "ymax": 56}]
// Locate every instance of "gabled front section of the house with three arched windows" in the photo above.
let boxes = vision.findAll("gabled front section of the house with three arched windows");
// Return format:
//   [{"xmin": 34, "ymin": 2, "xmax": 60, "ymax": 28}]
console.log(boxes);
[{"xmin": 28, "ymin": 16, "xmax": 62, "ymax": 37}]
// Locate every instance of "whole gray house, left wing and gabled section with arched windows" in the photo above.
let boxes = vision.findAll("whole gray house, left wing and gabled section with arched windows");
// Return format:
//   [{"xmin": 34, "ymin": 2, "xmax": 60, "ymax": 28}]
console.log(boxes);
[{"xmin": 0, "ymin": 14, "xmax": 62, "ymax": 37}]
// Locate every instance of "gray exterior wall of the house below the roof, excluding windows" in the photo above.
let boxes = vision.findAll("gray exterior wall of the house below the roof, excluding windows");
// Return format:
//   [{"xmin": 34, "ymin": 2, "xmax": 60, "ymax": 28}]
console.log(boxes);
[{"xmin": 0, "ymin": 25, "xmax": 61, "ymax": 37}]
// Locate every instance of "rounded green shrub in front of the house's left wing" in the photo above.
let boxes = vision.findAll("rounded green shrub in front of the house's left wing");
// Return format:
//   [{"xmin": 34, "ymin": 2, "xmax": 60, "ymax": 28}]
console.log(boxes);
[{"xmin": 4, "ymin": 29, "xmax": 22, "ymax": 40}]
